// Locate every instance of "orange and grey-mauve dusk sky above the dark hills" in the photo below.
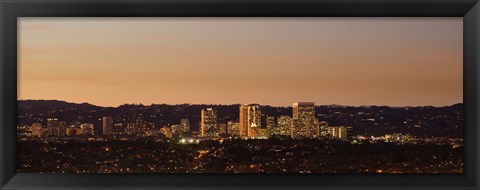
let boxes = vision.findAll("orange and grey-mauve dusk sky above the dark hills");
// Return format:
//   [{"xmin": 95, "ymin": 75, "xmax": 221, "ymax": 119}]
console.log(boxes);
[{"xmin": 18, "ymin": 17, "xmax": 463, "ymax": 106}]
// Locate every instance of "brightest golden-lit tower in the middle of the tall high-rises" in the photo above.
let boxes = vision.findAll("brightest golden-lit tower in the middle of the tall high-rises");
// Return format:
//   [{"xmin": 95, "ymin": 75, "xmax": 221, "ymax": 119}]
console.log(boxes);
[{"xmin": 239, "ymin": 104, "xmax": 262, "ymax": 138}]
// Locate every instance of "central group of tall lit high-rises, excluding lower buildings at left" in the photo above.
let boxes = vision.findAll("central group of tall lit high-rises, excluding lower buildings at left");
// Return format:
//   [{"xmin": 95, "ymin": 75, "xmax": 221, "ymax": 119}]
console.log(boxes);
[{"xmin": 197, "ymin": 102, "xmax": 347, "ymax": 139}]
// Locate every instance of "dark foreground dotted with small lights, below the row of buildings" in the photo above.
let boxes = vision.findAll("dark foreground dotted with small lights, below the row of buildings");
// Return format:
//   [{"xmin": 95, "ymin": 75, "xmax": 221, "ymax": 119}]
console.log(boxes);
[{"xmin": 17, "ymin": 138, "xmax": 463, "ymax": 173}]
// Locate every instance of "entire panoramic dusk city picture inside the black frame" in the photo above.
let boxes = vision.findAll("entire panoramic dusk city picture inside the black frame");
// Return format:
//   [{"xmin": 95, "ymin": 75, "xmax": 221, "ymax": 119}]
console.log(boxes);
[{"xmin": 15, "ymin": 17, "xmax": 465, "ymax": 174}]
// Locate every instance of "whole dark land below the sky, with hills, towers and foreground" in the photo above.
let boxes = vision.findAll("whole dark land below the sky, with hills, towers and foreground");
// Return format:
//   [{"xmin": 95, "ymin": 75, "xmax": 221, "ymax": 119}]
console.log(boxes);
[{"xmin": 17, "ymin": 100, "xmax": 463, "ymax": 173}]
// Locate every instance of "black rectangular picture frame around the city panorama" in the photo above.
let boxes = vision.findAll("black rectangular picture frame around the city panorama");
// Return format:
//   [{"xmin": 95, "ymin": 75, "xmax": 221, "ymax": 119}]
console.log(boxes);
[{"xmin": 0, "ymin": 0, "xmax": 480, "ymax": 190}]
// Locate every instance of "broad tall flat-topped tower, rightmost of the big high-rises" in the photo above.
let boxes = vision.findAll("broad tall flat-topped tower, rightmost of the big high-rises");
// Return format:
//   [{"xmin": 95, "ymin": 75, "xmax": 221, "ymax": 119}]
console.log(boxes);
[{"xmin": 292, "ymin": 102, "xmax": 318, "ymax": 138}]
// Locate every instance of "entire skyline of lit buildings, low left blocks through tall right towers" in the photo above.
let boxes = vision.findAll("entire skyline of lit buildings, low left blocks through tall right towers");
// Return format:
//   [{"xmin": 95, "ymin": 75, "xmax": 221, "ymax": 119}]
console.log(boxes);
[{"xmin": 21, "ymin": 102, "xmax": 347, "ymax": 139}]
